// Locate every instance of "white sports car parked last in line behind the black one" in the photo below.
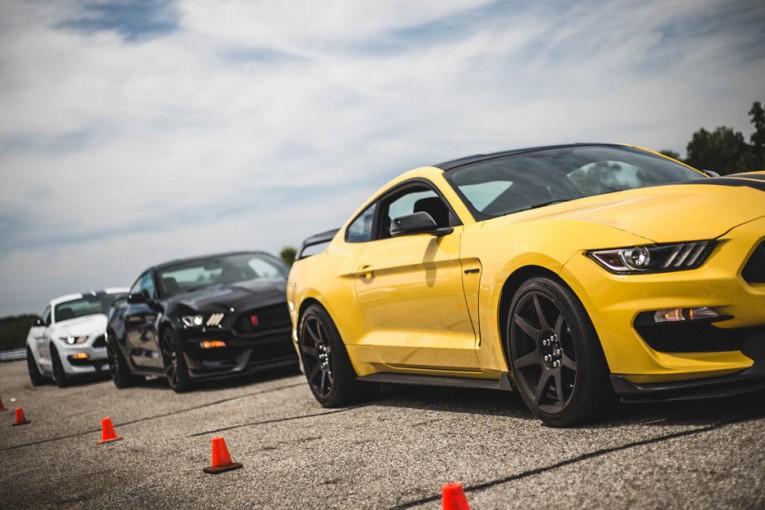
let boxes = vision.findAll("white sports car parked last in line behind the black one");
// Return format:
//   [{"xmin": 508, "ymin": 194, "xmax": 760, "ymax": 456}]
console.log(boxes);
[{"xmin": 27, "ymin": 288, "xmax": 129, "ymax": 388}]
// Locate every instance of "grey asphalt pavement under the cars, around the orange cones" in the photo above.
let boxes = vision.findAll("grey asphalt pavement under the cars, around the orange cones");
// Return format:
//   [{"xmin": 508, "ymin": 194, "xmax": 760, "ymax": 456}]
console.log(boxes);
[{"xmin": 0, "ymin": 361, "xmax": 765, "ymax": 510}]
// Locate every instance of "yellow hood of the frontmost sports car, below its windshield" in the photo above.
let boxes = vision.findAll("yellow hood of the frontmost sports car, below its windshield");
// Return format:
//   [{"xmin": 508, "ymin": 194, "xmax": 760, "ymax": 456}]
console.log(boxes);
[{"xmin": 520, "ymin": 172, "xmax": 765, "ymax": 243}]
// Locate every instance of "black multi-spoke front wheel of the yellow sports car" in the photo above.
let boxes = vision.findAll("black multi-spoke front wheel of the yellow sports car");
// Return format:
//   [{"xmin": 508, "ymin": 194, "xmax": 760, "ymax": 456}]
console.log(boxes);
[{"xmin": 506, "ymin": 278, "xmax": 613, "ymax": 427}]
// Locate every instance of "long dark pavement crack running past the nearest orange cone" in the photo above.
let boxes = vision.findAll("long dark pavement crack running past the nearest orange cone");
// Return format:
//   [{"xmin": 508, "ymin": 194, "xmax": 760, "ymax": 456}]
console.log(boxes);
[{"xmin": 390, "ymin": 414, "xmax": 762, "ymax": 510}]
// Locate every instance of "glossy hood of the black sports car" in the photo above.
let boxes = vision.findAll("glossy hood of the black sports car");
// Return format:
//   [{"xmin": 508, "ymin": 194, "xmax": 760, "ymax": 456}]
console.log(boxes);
[{"xmin": 170, "ymin": 278, "xmax": 287, "ymax": 313}]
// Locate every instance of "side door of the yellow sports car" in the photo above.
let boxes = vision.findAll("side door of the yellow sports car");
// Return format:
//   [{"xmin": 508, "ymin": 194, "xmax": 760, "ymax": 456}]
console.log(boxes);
[{"xmin": 354, "ymin": 187, "xmax": 478, "ymax": 372}]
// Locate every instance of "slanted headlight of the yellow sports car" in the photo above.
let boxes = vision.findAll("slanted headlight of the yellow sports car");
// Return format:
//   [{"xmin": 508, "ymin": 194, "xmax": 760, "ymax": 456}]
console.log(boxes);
[{"xmin": 587, "ymin": 241, "xmax": 716, "ymax": 274}]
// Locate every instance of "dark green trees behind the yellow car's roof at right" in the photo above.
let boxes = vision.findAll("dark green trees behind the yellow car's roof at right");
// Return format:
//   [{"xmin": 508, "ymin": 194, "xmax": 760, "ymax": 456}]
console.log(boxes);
[{"xmin": 661, "ymin": 101, "xmax": 765, "ymax": 175}]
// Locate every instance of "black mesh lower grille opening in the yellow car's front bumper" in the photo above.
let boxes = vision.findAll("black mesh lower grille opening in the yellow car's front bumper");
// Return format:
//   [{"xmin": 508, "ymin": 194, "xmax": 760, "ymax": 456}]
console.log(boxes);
[{"xmin": 635, "ymin": 323, "xmax": 765, "ymax": 352}]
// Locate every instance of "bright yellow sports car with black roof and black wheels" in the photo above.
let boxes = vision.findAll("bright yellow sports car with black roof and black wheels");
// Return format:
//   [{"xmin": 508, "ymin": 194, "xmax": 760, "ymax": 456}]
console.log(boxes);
[{"xmin": 287, "ymin": 144, "xmax": 765, "ymax": 426}]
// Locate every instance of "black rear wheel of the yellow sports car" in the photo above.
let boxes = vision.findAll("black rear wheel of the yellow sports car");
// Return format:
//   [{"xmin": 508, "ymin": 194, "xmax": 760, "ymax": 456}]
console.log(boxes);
[{"xmin": 298, "ymin": 305, "xmax": 378, "ymax": 407}]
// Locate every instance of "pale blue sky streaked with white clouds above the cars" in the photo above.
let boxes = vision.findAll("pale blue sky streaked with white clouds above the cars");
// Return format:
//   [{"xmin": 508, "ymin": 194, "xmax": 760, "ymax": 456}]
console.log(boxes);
[{"xmin": 0, "ymin": 0, "xmax": 765, "ymax": 317}]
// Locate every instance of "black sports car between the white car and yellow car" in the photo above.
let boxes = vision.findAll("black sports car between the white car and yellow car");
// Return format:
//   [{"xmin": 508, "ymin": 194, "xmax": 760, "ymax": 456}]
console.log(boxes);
[{"xmin": 106, "ymin": 252, "xmax": 297, "ymax": 392}]
